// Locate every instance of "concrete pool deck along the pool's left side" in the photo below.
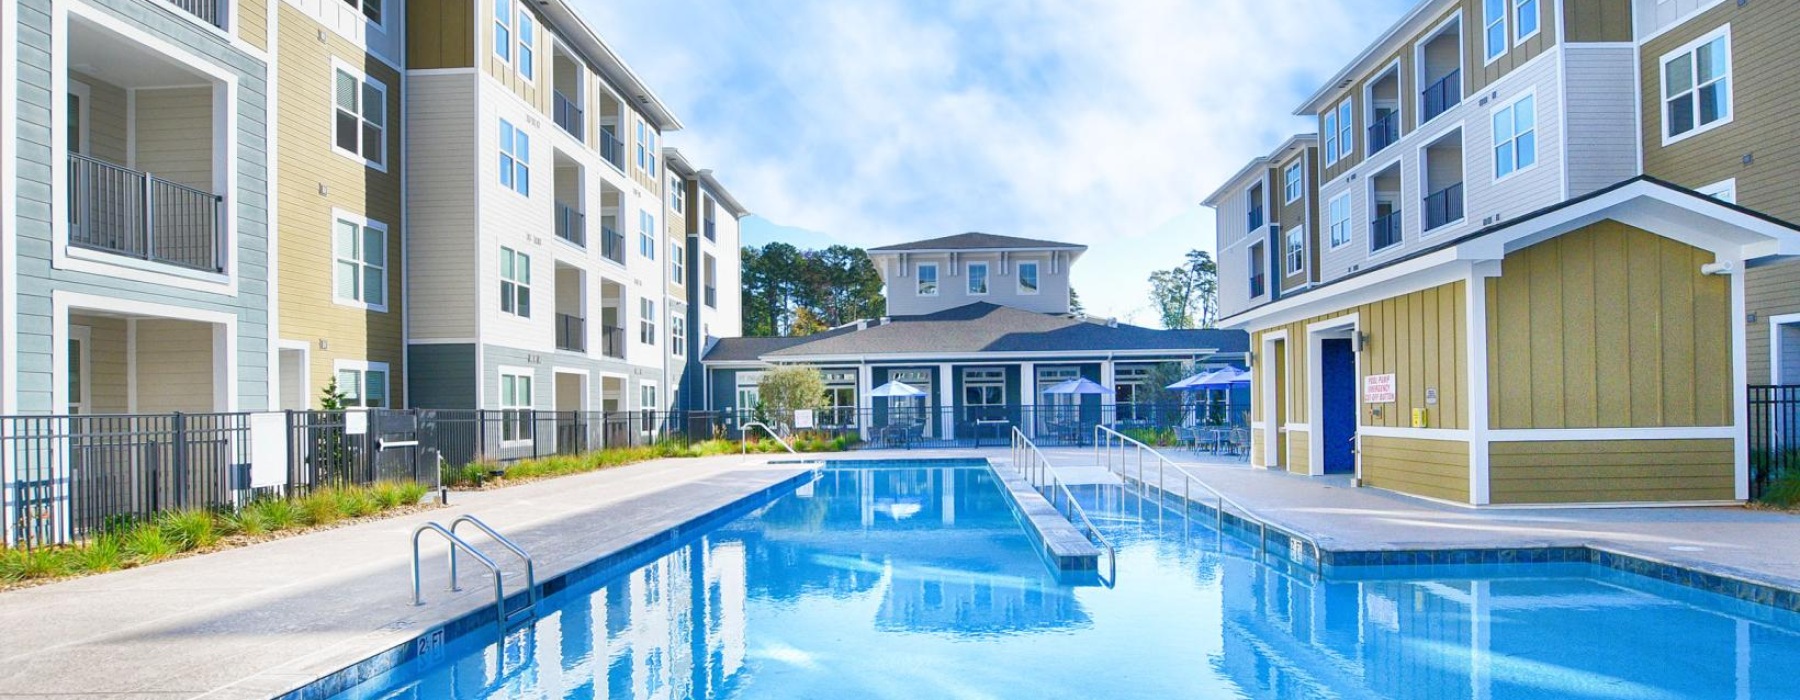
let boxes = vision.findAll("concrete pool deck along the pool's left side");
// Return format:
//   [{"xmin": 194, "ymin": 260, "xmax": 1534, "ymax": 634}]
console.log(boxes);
[{"xmin": 0, "ymin": 455, "xmax": 812, "ymax": 698}]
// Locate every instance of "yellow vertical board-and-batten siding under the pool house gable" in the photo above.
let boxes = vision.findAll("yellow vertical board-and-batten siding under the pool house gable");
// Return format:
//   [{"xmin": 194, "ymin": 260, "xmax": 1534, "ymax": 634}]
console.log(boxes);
[{"xmin": 1487, "ymin": 221, "xmax": 1733, "ymax": 430}]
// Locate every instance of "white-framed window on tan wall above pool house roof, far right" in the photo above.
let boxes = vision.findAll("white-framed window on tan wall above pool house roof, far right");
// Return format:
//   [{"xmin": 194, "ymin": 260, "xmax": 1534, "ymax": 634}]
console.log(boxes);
[{"xmin": 1661, "ymin": 25, "xmax": 1732, "ymax": 144}]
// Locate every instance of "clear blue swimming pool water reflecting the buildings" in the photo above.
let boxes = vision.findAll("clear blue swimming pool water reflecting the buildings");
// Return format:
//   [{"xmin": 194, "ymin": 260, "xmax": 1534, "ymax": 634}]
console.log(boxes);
[{"xmin": 331, "ymin": 464, "xmax": 1800, "ymax": 700}]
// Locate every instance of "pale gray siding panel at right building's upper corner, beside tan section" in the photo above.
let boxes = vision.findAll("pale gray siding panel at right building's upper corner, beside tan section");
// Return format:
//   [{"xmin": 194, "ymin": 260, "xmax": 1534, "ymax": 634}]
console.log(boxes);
[{"xmin": 1564, "ymin": 47, "xmax": 1638, "ymax": 196}]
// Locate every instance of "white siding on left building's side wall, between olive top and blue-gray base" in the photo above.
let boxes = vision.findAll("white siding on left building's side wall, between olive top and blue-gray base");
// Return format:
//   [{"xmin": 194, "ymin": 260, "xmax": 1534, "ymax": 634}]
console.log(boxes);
[{"xmin": 405, "ymin": 72, "xmax": 478, "ymax": 340}]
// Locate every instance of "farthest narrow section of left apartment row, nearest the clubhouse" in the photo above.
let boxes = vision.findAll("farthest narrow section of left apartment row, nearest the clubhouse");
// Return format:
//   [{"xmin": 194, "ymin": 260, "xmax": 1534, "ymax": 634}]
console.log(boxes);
[{"xmin": 662, "ymin": 148, "xmax": 751, "ymax": 410}]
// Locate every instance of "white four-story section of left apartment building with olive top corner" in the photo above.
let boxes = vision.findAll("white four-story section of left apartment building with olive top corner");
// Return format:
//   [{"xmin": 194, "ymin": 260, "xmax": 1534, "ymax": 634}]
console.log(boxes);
[{"xmin": 403, "ymin": 0, "xmax": 680, "ymax": 424}]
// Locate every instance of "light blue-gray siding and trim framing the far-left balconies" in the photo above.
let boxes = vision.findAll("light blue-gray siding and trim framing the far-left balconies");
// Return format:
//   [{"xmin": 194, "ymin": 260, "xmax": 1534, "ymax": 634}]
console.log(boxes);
[{"xmin": 11, "ymin": 0, "xmax": 270, "ymax": 412}]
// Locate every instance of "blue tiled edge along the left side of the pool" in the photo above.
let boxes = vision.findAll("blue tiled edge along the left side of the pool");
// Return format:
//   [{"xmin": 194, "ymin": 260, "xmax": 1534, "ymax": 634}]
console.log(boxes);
[{"xmin": 275, "ymin": 466, "xmax": 823, "ymax": 700}]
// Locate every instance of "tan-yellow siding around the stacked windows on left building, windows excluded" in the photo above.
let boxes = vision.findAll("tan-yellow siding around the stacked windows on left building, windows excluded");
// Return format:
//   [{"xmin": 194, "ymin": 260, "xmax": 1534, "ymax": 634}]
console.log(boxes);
[{"xmin": 275, "ymin": 4, "xmax": 405, "ymax": 405}]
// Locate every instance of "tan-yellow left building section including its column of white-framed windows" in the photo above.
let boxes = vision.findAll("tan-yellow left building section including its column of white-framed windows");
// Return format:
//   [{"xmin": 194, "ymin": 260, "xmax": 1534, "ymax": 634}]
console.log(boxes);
[{"xmin": 272, "ymin": 0, "xmax": 409, "ymax": 408}]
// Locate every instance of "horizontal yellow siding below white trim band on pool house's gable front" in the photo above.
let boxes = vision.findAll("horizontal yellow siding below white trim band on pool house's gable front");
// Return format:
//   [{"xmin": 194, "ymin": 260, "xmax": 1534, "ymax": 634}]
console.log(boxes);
[{"xmin": 1489, "ymin": 439, "xmax": 1735, "ymax": 504}]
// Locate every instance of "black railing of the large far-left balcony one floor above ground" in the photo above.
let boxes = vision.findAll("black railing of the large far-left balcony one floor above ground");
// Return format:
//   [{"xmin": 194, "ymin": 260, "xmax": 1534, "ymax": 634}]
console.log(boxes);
[{"xmin": 68, "ymin": 153, "xmax": 225, "ymax": 272}]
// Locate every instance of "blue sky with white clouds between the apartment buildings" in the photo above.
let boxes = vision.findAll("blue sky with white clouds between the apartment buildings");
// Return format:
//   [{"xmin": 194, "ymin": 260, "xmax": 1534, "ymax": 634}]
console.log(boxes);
[{"xmin": 571, "ymin": 0, "xmax": 1415, "ymax": 326}]
